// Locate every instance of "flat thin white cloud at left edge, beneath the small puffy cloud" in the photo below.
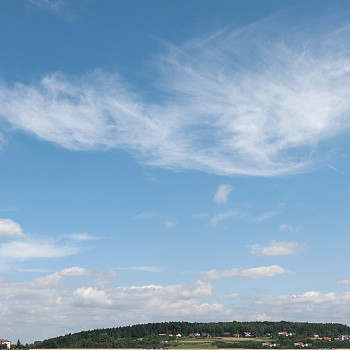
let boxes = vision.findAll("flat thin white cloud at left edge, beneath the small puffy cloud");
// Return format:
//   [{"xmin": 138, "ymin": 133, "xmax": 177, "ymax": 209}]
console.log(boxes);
[{"xmin": 0, "ymin": 239, "xmax": 79, "ymax": 261}]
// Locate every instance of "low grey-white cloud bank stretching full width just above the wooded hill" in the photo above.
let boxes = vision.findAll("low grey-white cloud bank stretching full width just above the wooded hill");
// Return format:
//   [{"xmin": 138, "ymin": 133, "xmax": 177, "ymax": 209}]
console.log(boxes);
[{"xmin": 0, "ymin": 266, "xmax": 350, "ymax": 342}]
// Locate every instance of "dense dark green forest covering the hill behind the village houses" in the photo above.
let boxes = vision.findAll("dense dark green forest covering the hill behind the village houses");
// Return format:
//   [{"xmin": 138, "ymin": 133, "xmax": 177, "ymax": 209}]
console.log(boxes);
[{"xmin": 31, "ymin": 321, "xmax": 350, "ymax": 349}]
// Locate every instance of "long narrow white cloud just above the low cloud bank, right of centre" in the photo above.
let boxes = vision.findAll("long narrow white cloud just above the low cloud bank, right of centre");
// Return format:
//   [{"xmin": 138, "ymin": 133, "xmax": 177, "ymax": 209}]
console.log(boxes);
[{"xmin": 199, "ymin": 265, "xmax": 286, "ymax": 281}]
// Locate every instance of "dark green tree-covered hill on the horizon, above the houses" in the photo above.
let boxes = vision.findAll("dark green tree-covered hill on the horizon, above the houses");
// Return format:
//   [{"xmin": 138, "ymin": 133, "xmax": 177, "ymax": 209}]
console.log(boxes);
[{"xmin": 33, "ymin": 321, "xmax": 350, "ymax": 348}]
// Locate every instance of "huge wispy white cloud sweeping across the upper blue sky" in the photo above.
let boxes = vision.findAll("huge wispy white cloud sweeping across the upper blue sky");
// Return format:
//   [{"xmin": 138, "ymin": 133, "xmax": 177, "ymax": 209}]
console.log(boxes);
[{"xmin": 0, "ymin": 15, "xmax": 350, "ymax": 176}]
